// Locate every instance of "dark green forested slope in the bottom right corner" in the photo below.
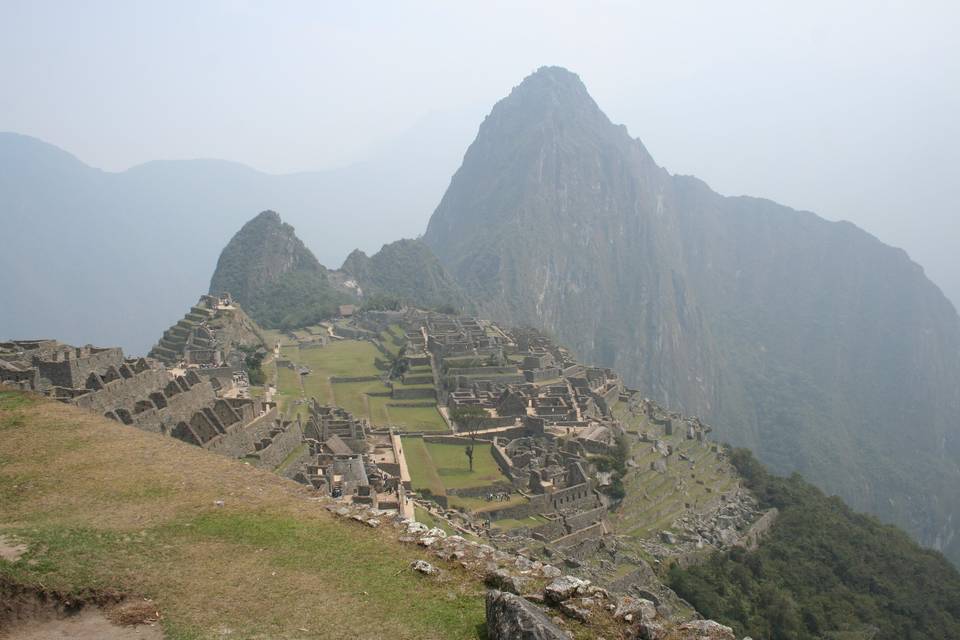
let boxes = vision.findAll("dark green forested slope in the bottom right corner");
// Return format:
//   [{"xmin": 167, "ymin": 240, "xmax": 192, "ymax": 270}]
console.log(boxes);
[{"xmin": 669, "ymin": 449, "xmax": 960, "ymax": 640}]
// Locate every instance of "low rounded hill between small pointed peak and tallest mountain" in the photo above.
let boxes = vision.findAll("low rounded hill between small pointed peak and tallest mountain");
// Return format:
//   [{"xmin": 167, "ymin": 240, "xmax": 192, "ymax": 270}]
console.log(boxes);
[{"xmin": 340, "ymin": 240, "xmax": 469, "ymax": 311}]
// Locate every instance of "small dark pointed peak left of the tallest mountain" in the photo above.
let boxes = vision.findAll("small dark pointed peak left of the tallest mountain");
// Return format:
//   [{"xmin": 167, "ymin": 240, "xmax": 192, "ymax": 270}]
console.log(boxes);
[{"xmin": 210, "ymin": 211, "xmax": 354, "ymax": 328}]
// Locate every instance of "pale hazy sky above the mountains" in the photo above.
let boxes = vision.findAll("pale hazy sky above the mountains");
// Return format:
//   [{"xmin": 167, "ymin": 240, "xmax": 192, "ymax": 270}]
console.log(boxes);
[{"xmin": 0, "ymin": 0, "xmax": 960, "ymax": 301}]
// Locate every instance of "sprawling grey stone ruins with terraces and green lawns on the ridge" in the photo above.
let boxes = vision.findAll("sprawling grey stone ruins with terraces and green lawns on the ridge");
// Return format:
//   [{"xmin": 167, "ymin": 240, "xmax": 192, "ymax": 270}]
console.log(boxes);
[{"xmin": 0, "ymin": 293, "xmax": 766, "ymax": 636}]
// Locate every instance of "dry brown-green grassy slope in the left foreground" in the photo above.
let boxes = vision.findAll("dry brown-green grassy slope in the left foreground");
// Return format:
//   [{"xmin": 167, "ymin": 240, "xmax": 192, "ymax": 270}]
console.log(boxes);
[{"xmin": 0, "ymin": 391, "xmax": 484, "ymax": 639}]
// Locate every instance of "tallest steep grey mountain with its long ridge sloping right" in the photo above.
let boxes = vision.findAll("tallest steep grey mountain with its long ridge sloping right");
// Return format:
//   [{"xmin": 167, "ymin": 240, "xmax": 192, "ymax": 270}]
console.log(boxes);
[{"xmin": 424, "ymin": 68, "xmax": 960, "ymax": 561}]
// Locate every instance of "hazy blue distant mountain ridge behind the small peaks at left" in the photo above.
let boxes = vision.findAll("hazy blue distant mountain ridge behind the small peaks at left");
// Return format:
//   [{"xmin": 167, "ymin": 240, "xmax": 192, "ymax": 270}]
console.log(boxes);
[{"xmin": 0, "ymin": 118, "xmax": 473, "ymax": 354}]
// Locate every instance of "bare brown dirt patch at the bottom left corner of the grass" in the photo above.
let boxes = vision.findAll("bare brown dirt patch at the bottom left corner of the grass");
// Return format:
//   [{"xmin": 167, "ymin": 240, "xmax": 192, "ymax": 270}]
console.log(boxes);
[{"xmin": 0, "ymin": 581, "xmax": 163, "ymax": 640}]
